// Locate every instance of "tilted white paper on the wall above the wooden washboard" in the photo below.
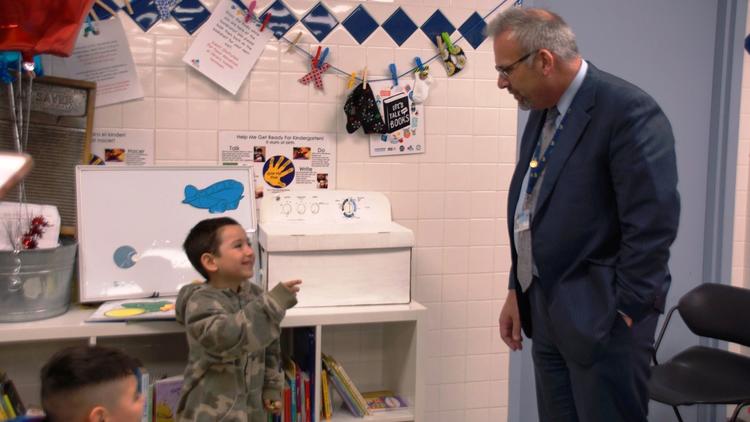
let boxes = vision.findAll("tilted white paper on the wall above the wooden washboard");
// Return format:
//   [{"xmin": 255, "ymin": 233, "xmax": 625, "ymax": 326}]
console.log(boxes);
[{"xmin": 45, "ymin": 19, "xmax": 143, "ymax": 107}]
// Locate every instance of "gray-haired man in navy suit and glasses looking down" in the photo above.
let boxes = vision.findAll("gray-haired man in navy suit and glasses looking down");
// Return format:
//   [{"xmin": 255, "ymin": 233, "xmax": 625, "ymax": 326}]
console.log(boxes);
[{"xmin": 494, "ymin": 8, "xmax": 680, "ymax": 422}]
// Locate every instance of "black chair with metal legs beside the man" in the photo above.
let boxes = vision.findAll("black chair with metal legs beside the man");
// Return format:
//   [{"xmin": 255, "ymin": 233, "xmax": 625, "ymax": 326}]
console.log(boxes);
[{"xmin": 649, "ymin": 283, "xmax": 750, "ymax": 422}]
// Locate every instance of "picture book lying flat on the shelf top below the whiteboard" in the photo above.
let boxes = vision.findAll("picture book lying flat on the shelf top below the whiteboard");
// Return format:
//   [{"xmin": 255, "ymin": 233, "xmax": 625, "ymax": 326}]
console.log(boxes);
[{"xmin": 86, "ymin": 297, "xmax": 177, "ymax": 322}]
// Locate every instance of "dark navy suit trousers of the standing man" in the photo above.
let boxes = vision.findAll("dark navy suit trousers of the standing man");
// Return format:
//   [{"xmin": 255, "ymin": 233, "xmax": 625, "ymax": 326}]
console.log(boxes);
[{"xmin": 527, "ymin": 277, "xmax": 659, "ymax": 422}]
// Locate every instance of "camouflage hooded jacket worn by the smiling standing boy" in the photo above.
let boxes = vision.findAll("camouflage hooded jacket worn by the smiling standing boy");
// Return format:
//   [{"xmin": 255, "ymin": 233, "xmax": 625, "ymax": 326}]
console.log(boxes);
[{"xmin": 175, "ymin": 282, "xmax": 297, "ymax": 422}]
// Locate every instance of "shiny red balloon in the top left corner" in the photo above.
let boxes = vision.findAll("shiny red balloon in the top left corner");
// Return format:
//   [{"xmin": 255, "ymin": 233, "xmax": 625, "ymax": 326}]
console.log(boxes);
[{"xmin": 0, "ymin": 0, "xmax": 94, "ymax": 62}]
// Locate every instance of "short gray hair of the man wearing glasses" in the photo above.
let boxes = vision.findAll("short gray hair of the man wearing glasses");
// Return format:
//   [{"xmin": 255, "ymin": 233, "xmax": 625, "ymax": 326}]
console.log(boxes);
[{"xmin": 485, "ymin": 7, "xmax": 578, "ymax": 60}]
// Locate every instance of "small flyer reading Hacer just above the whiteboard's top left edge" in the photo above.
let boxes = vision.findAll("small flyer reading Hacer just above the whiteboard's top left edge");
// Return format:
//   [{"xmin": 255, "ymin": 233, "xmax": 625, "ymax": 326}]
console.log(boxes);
[{"xmin": 89, "ymin": 129, "xmax": 154, "ymax": 166}]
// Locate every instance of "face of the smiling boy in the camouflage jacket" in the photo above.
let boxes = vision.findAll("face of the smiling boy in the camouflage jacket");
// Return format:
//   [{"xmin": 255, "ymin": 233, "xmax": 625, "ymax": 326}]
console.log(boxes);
[{"xmin": 214, "ymin": 225, "xmax": 255, "ymax": 282}]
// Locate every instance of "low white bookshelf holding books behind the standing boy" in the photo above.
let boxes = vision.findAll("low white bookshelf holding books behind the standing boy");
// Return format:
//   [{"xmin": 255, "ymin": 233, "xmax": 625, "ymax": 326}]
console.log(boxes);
[{"xmin": 0, "ymin": 302, "xmax": 426, "ymax": 422}]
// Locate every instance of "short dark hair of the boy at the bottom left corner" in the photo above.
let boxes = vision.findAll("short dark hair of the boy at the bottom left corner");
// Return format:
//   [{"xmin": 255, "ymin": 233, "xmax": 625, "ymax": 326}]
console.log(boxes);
[{"xmin": 41, "ymin": 346, "xmax": 141, "ymax": 422}]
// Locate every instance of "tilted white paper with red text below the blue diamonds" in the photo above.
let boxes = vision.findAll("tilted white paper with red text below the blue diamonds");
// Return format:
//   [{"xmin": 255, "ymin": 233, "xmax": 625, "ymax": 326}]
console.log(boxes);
[{"xmin": 182, "ymin": 0, "xmax": 273, "ymax": 95}]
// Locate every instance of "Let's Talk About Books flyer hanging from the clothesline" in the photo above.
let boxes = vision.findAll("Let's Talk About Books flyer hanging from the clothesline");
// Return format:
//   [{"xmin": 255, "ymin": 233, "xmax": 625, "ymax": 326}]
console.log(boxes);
[{"xmin": 370, "ymin": 78, "xmax": 425, "ymax": 157}]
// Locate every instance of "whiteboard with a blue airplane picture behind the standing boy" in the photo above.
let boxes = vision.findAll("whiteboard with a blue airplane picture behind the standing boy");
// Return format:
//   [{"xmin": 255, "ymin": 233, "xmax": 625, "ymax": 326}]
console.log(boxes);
[{"xmin": 76, "ymin": 166, "xmax": 257, "ymax": 303}]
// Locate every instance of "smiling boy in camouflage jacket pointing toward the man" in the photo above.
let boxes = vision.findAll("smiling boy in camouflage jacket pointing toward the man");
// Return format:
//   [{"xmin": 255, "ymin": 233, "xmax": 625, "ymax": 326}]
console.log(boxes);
[{"xmin": 176, "ymin": 217, "xmax": 302, "ymax": 422}]
